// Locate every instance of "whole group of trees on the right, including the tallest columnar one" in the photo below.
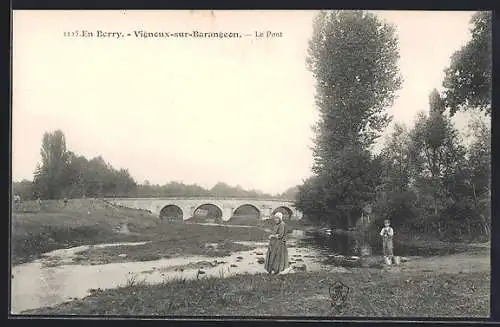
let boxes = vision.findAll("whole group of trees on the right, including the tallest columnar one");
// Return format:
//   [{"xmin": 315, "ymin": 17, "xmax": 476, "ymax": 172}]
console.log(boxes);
[{"xmin": 296, "ymin": 11, "xmax": 491, "ymax": 239}]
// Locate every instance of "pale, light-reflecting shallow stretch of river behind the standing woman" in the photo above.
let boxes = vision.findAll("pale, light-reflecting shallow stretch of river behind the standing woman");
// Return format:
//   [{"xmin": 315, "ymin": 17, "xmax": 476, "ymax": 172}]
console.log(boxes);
[{"xmin": 11, "ymin": 234, "xmax": 328, "ymax": 314}]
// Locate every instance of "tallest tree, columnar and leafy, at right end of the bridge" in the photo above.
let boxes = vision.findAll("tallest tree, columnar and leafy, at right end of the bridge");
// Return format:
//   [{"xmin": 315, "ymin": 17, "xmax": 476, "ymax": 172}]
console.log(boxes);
[{"xmin": 297, "ymin": 11, "xmax": 401, "ymax": 226}]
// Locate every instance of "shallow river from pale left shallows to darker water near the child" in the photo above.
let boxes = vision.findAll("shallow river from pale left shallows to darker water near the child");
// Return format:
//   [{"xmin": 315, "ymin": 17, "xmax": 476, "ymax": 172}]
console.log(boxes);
[{"xmin": 11, "ymin": 230, "xmax": 430, "ymax": 314}]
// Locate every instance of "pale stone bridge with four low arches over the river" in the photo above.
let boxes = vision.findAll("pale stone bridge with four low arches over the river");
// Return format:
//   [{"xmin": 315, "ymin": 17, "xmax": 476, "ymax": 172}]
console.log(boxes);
[{"xmin": 105, "ymin": 197, "xmax": 302, "ymax": 221}]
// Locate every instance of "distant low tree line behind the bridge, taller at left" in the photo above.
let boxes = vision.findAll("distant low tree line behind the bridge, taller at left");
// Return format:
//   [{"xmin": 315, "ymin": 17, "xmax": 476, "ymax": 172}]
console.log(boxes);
[{"xmin": 13, "ymin": 130, "xmax": 297, "ymax": 200}]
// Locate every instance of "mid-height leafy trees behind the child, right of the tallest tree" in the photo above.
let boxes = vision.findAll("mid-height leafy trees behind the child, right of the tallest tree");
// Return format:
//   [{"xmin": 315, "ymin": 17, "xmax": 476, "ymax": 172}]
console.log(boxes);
[{"xmin": 374, "ymin": 90, "xmax": 491, "ymax": 240}]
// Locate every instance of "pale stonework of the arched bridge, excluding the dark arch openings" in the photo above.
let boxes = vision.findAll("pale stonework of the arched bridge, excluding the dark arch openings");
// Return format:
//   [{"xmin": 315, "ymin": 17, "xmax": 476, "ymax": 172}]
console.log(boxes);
[{"xmin": 106, "ymin": 198, "xmax": 302, "ymax": 221}]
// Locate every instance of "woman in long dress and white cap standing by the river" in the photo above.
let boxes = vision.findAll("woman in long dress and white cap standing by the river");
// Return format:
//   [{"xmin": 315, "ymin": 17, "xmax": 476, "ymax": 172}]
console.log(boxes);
[{"xmin": 264, "ymin": 212, "xmax": 288, "ymax": 275}]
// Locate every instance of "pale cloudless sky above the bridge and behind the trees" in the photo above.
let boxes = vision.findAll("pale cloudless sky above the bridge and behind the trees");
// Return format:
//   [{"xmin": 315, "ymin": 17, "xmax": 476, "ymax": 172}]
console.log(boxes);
[{"xmin": 12, "ymin": 10, "xmax": 486, "ymax": 194}]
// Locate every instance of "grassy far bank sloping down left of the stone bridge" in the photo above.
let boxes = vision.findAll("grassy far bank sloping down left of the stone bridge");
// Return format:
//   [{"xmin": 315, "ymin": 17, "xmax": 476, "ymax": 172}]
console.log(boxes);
[{"xmin": 11, "ymin": 199, "xmax": 267, "ymax": 264}]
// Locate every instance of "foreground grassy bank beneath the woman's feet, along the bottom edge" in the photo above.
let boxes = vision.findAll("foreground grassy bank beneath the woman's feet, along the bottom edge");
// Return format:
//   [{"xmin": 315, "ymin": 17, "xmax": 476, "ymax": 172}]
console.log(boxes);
[{"xmin": 23, "ymin": 269, "xmax": 490, "ymax": 317}]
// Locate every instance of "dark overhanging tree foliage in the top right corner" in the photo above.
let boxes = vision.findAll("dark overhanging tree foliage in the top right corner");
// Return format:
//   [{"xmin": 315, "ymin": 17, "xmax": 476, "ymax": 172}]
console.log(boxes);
[{"xmin": 443, "ymin": 11, "xmax": 492, "ymax": 116}]
